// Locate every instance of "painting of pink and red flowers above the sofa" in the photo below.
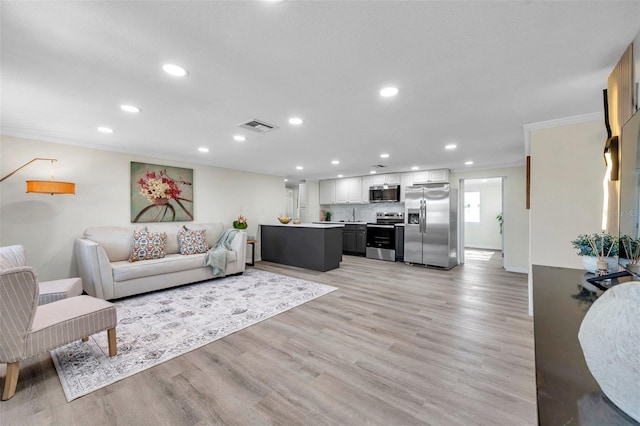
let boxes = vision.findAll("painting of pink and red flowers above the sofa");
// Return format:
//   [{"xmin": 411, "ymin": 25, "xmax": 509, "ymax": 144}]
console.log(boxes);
[{"xmin": 131, "ymin": 162, "xmax": 193, "ymax": 223}]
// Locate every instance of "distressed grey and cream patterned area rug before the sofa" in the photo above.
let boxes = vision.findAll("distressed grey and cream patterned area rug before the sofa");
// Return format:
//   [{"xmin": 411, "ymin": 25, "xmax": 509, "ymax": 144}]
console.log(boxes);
[{"xmin": 51, "ymin": 269, "xmax": 336, "ymax": 401}]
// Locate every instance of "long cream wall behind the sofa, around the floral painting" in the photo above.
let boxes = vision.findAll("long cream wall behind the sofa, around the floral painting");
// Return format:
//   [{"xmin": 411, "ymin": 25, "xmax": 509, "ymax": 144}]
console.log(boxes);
[{"xmin": 0, "ymin": 136, "xmax": 284, "ymax": 280}]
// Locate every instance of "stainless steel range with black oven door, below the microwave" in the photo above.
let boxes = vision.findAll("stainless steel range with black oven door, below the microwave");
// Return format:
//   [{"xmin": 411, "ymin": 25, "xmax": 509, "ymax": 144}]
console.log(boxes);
[{"xmin": 366, "ymin": 212, "xmax": 404, "ymax": 262}]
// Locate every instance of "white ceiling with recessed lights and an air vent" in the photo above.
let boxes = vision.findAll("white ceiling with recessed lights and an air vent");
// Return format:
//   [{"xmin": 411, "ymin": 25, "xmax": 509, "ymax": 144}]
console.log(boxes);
[{"xmin": 0, "ymin": 0, "xmax": 640, "ymax": 186}]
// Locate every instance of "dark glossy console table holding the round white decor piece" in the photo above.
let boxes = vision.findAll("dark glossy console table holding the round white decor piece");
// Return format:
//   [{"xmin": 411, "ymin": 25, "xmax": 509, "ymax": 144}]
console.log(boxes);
[{"xmin": 533, "ymin": 265, "xmax": 640, "ymax": 426}]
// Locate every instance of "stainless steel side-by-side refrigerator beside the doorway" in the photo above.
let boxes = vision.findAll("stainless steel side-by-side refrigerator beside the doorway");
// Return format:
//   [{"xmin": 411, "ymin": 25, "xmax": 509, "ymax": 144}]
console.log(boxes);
[{"xmin": 404, "ymin": 183, "xmax": 458, "ymax": 269}]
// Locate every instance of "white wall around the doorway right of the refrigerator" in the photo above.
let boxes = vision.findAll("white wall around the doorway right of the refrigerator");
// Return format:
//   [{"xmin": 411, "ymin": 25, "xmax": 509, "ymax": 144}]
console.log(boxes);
[{"xmin": 450, "ymin": 167, "xmax": 529, "ymax": 273}]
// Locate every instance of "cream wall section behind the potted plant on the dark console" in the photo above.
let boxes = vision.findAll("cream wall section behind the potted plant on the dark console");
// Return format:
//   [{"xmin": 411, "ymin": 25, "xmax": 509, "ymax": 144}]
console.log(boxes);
[{"xmin": 530, "ymin": 120, "xmax": 607, "ymax": 269}]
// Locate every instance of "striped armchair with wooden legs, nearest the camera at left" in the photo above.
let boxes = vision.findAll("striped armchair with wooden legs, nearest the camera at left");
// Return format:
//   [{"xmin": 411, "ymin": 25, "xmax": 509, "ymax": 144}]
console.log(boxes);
[{"xmin": 0, "ymin": 265, "xmax": 117, "ymax": 401}]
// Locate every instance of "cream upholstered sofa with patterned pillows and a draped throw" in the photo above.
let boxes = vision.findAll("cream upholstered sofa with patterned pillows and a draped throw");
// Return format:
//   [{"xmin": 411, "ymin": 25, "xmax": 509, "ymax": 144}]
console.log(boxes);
[{"xmin": 75, "ymin": 223, "xmax": 247, "ymax": 300}]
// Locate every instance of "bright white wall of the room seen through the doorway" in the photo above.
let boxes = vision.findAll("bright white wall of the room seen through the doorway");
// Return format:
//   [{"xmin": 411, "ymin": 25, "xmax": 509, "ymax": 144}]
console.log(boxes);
[{"xmin": 464, "ymin": 181, "xmax": 502, "ymax": 250}]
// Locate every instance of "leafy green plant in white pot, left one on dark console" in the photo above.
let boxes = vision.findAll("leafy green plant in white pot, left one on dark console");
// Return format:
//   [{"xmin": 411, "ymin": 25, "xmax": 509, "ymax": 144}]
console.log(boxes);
[{"xmin": 571, "ymin": 231, "xmax": 618, "ymax": 273}]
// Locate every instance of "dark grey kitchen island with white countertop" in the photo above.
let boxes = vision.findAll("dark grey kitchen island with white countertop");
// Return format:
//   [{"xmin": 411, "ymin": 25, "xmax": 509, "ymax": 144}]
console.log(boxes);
[{"xmin": 260, "ymin": 223, "xmax": 344, "ymax": 272}]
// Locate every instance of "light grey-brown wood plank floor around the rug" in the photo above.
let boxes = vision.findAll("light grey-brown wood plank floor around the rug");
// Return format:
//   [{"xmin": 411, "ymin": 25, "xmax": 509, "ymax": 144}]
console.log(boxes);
[{"xmin": 0, "ymin": 250, "xmax": 536, "ymax": 426}]
